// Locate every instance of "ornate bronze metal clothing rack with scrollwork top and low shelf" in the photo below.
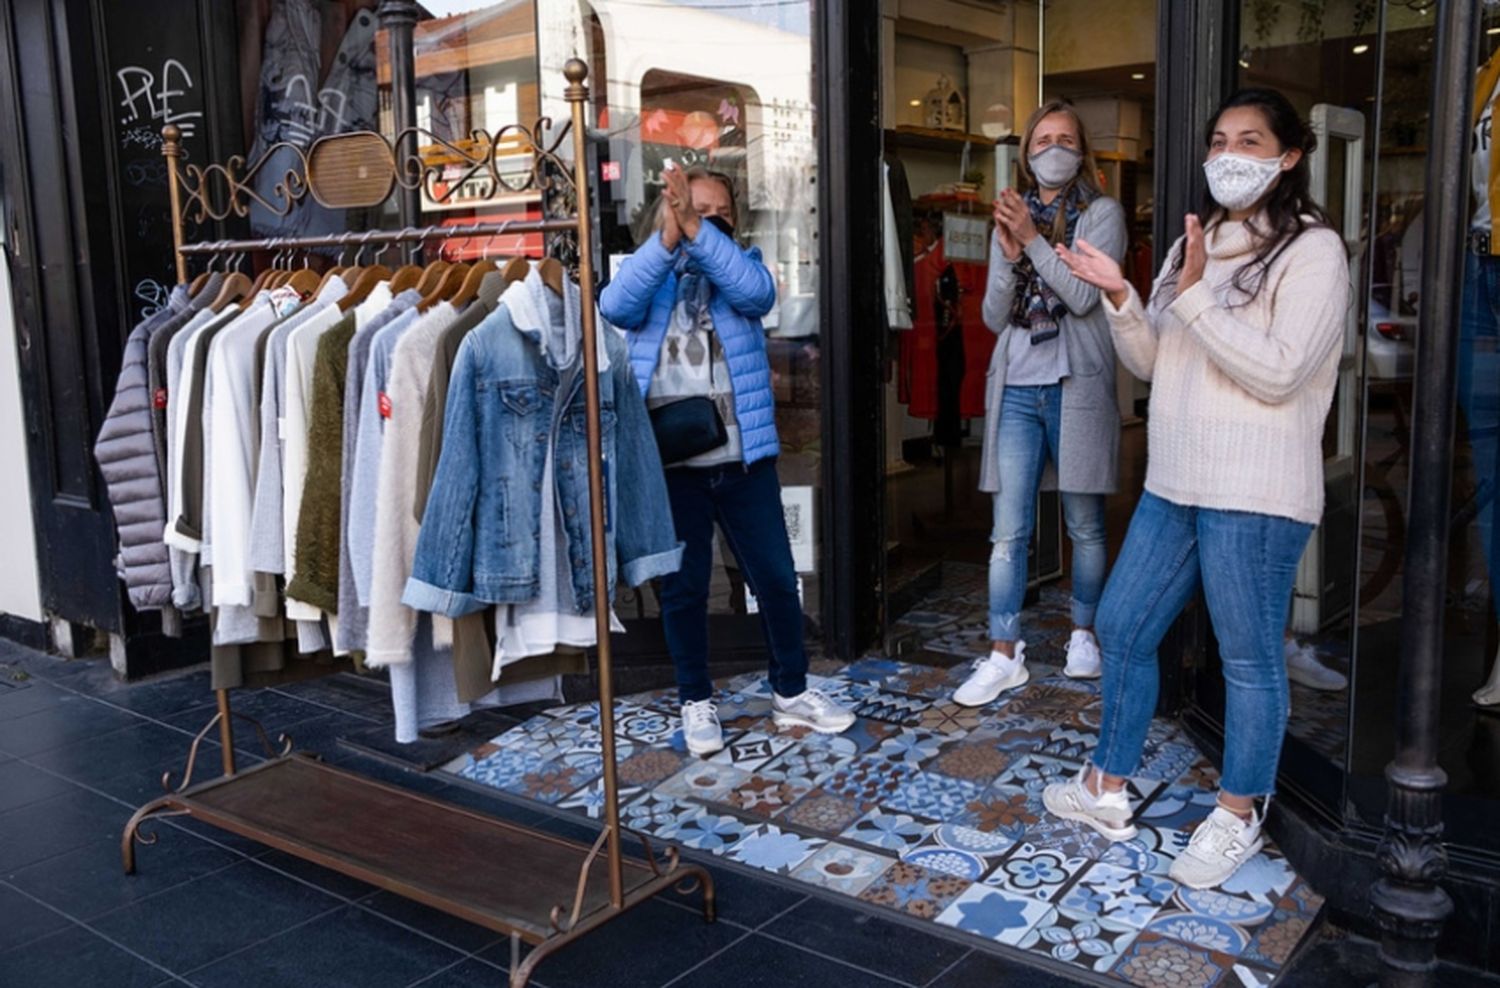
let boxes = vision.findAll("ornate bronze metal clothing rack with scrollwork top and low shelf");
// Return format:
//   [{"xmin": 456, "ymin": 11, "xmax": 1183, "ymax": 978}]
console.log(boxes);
[{"xmin": 122, "ymin": 58, "xmax": 716, "ymax": 988}]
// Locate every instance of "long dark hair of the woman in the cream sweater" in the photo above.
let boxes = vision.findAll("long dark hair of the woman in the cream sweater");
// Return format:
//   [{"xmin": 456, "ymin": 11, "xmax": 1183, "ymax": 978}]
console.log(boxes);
[{"xmin": 1161, "ymin": 88, "xmax": 1334, "ymax": 303}]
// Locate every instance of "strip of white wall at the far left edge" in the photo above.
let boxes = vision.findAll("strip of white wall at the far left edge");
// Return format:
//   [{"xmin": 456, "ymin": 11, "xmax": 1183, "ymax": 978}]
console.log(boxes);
[{"xmin": 0, "ymin": 252, "xmax": 42, "ymax": 621}]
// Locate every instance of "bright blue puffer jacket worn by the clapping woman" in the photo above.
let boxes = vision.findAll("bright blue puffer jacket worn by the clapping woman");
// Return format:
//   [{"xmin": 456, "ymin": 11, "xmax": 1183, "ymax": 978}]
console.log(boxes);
[{"xmin": 599, "ymin": 222, "xmax": 782, "ymax": 466}]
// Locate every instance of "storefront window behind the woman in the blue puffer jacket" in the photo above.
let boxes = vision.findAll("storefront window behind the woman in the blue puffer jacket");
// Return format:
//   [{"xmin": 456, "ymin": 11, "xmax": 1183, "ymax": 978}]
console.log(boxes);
[{"xmin": 537, "ymin": 0, "xmax": 822, "ymax": 626}]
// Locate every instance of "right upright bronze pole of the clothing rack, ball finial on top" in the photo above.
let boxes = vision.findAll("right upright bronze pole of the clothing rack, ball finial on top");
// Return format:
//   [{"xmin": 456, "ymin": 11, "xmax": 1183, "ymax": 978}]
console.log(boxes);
[{"xmin": 563, "ymin": 58, "xmax": 626, "ymax": 909}]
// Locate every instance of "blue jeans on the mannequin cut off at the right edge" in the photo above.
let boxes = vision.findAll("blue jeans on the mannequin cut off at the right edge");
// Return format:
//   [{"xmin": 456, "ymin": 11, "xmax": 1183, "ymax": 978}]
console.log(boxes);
[{"xmin": 1458, "ymin": 253, "xmax": 1500, "ymax": 623}]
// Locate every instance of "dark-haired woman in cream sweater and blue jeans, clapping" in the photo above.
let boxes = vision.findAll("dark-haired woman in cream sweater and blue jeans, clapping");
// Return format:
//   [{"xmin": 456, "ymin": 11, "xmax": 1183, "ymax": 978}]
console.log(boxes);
[{"xmin": 1044, "ymin": 90, "xmax": 1349, "ymax": 889}]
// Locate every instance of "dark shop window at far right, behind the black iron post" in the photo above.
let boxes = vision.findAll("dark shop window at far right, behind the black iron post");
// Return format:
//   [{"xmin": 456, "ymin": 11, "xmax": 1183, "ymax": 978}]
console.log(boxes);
[{"xmin": 1350, "ymin": 3, "xmax": 1500, "ymax": 850}]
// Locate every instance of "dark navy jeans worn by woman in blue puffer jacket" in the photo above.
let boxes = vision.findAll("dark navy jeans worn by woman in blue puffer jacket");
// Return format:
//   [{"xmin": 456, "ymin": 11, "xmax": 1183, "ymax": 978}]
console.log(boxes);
[{"xmin": 660, "ymin": 459, "xmax": 807, "ymax": 703}]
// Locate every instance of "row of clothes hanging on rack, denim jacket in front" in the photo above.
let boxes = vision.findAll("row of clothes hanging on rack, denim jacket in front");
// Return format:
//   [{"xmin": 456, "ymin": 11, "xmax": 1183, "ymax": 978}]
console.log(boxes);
[{"xmin": 96, "ymin": 251, "xmax": 642, "ymax": 742}]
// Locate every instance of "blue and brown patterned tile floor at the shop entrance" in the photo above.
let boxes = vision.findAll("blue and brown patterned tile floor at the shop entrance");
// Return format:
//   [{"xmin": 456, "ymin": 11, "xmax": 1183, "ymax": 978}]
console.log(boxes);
[{"xmin": 449, "ymin": 571, "xmax": 1322, "ymax": 988}]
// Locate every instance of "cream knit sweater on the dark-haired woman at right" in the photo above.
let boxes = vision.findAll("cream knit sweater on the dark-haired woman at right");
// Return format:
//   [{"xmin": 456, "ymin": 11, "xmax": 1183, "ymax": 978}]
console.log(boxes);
[{"xmin": 1104, "ymin": 215, "xmax": 1349, "ymax": 525}]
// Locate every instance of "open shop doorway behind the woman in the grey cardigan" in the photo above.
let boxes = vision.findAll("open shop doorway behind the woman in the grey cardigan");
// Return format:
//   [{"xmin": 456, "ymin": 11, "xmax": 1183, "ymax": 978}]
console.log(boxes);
[{"xmin": 873, "ymin": 0, "xmax": 1157, "ymax": 664}]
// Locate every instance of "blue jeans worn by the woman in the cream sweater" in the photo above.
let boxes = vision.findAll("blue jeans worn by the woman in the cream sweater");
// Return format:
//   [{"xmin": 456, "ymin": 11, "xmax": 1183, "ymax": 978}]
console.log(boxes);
[{"xmin": 1094, "ymin": 492, "xmax": 1313, "ymax": 796}]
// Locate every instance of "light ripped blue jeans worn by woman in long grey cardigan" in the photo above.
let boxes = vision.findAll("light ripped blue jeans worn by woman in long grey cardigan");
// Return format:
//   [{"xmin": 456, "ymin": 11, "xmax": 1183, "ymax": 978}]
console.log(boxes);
[{"xmin": 990, "ymin": 384, "xmax": 1107, "ymax": 642}]
